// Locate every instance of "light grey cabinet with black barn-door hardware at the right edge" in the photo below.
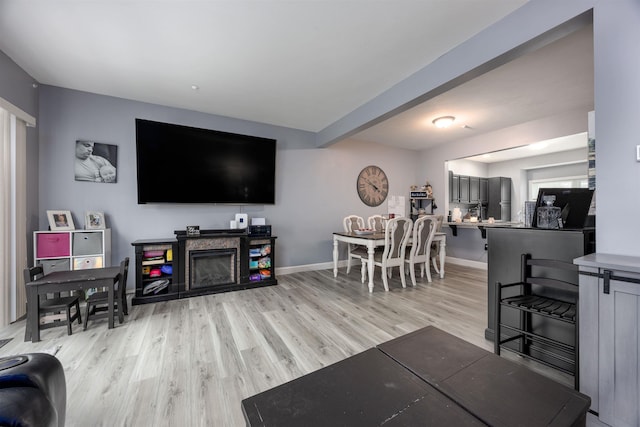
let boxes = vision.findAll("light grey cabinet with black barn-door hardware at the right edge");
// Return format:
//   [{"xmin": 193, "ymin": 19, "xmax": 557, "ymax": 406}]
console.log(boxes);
[{"xmin": 574, "ymin": 253, "xmax": 640, "ymax": 426}]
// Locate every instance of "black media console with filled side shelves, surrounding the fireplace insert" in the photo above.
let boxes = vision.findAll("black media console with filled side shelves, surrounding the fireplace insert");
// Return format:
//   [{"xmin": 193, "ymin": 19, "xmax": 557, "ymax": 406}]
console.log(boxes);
[{"xmin": 132, "ymin": 234, "xmax": 278, "ymax": 305}]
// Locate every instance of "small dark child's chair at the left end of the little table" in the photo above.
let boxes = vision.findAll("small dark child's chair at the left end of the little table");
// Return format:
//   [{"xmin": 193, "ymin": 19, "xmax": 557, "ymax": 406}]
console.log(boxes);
[{"xmin": 24, "ymin": 265, "xmax": 82, "ymax": 341}]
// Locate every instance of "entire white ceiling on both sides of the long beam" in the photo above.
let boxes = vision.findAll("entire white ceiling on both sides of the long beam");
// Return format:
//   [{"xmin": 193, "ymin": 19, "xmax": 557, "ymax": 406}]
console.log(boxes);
[{"xmin": 0, "ymin": 0, "xmax": 593, "ymax": 160}]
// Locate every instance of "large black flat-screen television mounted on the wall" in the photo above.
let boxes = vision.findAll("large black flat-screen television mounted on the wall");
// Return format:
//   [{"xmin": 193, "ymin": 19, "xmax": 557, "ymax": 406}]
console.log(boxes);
[{"xmin": 136, "ymin": 119, "xmax": 276, "ymax": 204}]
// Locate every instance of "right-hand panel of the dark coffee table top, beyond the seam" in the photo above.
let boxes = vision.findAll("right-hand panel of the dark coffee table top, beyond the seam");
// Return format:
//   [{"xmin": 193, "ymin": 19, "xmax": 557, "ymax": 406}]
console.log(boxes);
[{"xmin": 378, "ymin": 327, "xmax": 591, "ymax": 426}]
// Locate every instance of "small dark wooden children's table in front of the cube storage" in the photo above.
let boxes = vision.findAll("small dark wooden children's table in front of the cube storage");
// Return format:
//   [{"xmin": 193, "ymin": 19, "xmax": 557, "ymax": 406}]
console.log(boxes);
[{"xmin": 27, "ymin": 267, "xmax": 124, "ymax": 342}]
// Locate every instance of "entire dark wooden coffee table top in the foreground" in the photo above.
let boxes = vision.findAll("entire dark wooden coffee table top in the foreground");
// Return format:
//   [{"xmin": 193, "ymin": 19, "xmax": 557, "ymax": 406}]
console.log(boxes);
[{"xmin": 242, "ymin": 327, "xmax": 590, "ymax": 426}]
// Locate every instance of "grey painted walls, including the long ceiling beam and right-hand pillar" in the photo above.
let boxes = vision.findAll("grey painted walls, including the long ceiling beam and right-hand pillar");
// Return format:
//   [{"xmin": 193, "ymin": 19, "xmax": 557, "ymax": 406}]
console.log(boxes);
[{"xmin": 5, "ymin": 0, "xmax": 640, "ymax": 276}]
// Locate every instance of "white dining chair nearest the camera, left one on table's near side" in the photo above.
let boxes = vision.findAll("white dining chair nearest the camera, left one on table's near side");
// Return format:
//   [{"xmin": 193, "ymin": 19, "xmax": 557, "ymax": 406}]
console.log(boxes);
[{"xmin": 361, "ymin": 217, "xmax": 413, "ymax": 291}]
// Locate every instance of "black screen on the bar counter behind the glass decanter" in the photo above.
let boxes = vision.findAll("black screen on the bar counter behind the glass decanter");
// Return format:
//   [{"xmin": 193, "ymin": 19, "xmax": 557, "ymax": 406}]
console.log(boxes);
[{"xmin": 532, "ymin": 188, "xmax": 593, "ymax": 229}]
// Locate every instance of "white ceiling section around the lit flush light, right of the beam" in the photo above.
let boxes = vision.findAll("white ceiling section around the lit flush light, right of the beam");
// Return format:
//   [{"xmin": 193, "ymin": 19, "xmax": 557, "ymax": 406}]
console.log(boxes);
[{"xmin": 354, "ymin": 22, "xmax": 594, "ymax": 150}]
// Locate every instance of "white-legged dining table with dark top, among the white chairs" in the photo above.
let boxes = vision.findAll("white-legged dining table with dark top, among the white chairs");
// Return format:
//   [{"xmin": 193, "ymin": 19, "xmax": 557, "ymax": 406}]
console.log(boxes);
[{"xmin": 333, "ymin": 231, "xmax": 447, "ymax": 292}]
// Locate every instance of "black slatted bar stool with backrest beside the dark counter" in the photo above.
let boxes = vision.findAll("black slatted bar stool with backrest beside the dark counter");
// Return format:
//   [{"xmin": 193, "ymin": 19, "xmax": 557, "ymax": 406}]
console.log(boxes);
[{"xmin": 493, "ymin": 254, "xmax": 579, "ymax": 390}]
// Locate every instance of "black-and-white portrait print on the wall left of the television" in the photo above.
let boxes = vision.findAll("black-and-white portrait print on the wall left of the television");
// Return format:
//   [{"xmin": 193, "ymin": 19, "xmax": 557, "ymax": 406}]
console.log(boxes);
[{"xmin": 74, "ymin": 140, "xmax": 118, "ymax": 183}]
